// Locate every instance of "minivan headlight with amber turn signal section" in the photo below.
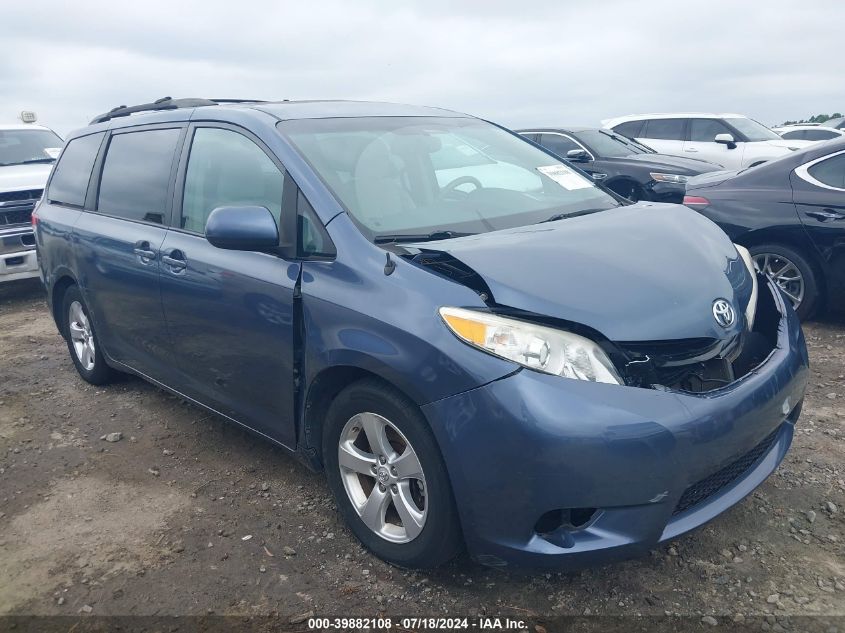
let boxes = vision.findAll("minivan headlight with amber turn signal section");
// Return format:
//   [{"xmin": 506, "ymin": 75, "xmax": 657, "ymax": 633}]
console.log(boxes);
[{"xmin": 440, "ymin": 308, "xmax": 622, "ymax": 385}]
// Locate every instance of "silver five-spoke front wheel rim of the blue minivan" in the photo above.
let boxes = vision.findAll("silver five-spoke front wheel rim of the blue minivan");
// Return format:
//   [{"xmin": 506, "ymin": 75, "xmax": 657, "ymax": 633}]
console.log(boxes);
[{"xmin": 337, "ymin": 413, "xmax": 428, "ymax": 543}]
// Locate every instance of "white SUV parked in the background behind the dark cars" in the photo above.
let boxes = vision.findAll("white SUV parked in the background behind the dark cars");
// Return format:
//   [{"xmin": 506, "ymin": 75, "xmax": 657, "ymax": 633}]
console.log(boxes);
[{"xmin": 601, "ymin": 112, "xmax": 810, "ymax": 169}]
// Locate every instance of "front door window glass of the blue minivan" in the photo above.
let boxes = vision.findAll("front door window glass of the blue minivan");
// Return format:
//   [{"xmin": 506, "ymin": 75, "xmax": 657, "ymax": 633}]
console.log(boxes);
[{"xmin": 181, "ymin": 128, "xmax": 284, "ymax": 234}]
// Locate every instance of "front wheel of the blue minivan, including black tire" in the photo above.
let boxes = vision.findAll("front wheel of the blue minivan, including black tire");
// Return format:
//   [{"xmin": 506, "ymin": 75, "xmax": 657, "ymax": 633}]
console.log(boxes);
[{"xmin": 323, "ymin": 379, "xmax": 463, "ymax": 569}]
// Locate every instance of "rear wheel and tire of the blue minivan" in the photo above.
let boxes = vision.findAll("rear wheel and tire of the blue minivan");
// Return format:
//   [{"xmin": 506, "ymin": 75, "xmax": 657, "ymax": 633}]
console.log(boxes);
[{"xmin": 62, "ymin": 286, "xmax": 115, "ymax": 385}]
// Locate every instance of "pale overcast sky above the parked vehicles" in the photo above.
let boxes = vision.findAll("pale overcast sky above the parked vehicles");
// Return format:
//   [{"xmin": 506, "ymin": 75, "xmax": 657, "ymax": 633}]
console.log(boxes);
[{"xmin": 0, "ymin": 0, "xmax": 845, "ymax": 133}]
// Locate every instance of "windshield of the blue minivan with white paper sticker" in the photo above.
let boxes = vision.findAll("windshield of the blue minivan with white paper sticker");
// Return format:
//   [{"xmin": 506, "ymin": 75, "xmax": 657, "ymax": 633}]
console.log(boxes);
[{"xmin": 279, "ymin": 117, "xmax": 619, "ymax": 241}]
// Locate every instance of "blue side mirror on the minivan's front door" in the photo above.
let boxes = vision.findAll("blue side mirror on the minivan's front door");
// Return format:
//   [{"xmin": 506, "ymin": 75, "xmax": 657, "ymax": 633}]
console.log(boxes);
[{"xmin": 205, "ymin": 207, "xmax": 279, "ymax": 251}]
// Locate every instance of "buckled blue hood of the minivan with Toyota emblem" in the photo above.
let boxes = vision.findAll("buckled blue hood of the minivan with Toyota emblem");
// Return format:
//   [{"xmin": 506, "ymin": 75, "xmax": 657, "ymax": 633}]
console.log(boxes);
[{"xmin": 415, "ymin": 202, "xmax": 752, "ymax": 342}]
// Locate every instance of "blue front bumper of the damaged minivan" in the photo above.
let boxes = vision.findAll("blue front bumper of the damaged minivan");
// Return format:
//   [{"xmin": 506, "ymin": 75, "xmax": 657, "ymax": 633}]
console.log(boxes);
[{"xmin": 423, "ymin": 282, "xmax": 808, "ymax": 568}]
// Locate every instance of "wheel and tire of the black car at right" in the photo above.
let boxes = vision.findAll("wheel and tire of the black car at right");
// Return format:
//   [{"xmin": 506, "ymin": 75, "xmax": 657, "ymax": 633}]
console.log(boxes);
[{"xmin": 748, "ymin": 244, "xmax": 820, "ymax": 321}]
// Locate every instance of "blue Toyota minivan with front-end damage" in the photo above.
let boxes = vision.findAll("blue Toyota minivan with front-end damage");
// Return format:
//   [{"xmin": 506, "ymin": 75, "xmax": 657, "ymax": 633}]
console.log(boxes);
[{"xmin": 33, "ymin": 99, "xmax": 808, "ymax": 568}]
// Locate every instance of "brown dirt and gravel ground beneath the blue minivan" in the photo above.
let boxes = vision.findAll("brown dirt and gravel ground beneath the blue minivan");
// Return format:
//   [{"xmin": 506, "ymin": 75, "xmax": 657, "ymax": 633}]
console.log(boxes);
[{"xmin": 0, "ymin": 282, "xmax": 845, "ymax": 630}]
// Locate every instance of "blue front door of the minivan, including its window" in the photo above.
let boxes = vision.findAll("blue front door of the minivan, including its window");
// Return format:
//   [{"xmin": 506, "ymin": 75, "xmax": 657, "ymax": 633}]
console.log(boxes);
[{"xmin": 161, "ymin": 126, "xmax": 300, "ymax": 446}]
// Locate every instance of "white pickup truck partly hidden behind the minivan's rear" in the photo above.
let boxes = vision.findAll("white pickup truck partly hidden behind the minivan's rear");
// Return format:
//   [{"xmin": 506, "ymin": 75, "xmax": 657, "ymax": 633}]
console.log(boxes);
[{"xmin": 0, "ymin": 113, "xmax": 64, "ymax": 283}]
